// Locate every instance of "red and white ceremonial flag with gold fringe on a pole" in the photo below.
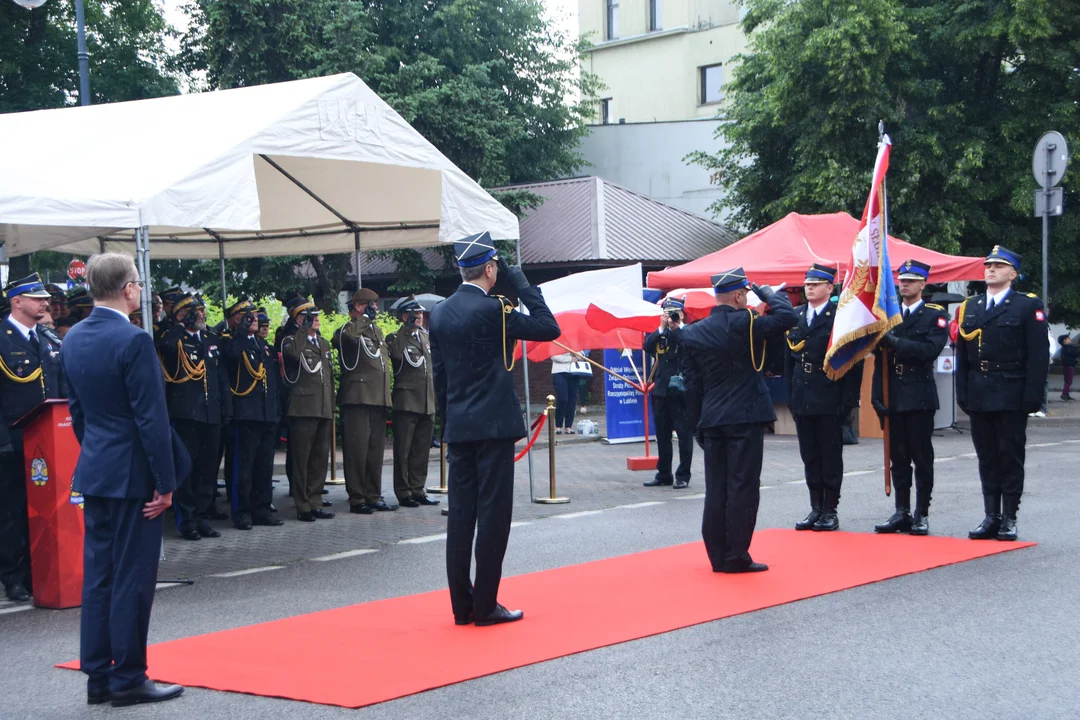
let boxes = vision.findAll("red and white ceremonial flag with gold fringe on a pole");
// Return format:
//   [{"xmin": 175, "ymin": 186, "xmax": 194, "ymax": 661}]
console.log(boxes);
[{"xmin": 825, "ymin": 135, "xmax": 902, "ymax": 380}]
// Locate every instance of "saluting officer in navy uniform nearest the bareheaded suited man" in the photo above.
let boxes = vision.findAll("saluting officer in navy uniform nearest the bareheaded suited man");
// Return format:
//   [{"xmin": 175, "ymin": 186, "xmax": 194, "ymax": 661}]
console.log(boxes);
[{"xmin": 159, "ymin": 294, "xmax": 232, "ymax": 540}]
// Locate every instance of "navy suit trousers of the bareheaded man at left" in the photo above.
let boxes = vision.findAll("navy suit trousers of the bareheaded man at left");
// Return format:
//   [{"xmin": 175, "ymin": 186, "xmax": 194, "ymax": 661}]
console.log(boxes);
[{"xmin": 79, "ymin": 496, "xmax": 162, "ymax": 692}]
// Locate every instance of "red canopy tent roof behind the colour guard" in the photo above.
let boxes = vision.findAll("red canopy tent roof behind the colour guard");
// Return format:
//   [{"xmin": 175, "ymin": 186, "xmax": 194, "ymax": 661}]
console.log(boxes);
[{"xmin": 648, "ymin": 213, "xmax": 983, "ymax": 289}]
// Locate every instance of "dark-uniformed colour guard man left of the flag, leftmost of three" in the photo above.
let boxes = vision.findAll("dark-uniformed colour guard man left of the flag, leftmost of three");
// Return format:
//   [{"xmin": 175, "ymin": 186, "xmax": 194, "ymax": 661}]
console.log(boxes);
[{"xmin": 785, "ymin": 263, "xmax": 863, "ymax": 531}]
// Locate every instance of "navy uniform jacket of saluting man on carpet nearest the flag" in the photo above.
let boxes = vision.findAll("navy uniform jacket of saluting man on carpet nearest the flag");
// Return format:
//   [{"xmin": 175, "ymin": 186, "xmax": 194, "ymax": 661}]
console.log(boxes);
[{"xmin": 681, "ymin": 293, "xmax": 797, "ymax": 430}]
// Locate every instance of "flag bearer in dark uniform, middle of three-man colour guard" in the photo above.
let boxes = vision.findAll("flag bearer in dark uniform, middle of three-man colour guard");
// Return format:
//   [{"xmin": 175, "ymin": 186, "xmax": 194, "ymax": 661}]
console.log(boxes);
[{"xmin": 872, "ymin": 260, "xmax": 948, "ymax": 535}]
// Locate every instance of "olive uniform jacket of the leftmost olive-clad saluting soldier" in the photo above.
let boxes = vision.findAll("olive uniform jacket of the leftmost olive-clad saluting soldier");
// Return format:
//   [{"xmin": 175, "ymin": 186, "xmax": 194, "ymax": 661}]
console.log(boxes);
[{"xmin": 281, "ymin": 328, "xmax": 334, "ymax": 420}]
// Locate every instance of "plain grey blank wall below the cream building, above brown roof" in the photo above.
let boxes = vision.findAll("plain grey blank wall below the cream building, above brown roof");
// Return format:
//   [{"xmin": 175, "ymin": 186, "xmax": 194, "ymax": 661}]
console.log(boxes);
[{"xmin": 581, "ymin": 120, "xmax": 723, "ymax": 219}]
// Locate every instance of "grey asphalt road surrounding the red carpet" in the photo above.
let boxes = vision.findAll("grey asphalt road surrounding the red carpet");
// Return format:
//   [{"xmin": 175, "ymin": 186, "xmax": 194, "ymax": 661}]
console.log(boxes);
[{"xmin": 0, "ymin": 427, "xmax": 1080, "ymax": 720}]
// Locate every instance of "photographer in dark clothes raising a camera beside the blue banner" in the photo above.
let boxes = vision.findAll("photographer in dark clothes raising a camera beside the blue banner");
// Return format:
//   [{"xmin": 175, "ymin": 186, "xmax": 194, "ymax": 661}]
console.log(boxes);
[{"xmin": 643, "ymin": 298, "xmax": 693, "ymax": 490}]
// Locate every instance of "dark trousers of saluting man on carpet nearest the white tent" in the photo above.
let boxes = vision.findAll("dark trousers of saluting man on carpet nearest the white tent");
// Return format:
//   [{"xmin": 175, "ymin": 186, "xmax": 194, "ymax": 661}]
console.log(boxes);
[{"xmin": 446, "ymin": 439, "xmax": 514, "ymax": 617}]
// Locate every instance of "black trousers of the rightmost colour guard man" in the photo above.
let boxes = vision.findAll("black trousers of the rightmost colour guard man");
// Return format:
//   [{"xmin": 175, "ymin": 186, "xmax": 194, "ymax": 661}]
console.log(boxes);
[{"xmin": 968, "ymin": 410, "xmax": 1027, "ymax": 500}]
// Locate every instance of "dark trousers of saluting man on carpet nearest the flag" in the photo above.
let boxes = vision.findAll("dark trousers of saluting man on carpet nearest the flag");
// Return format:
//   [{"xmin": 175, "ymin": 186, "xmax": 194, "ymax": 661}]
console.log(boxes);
[{"xmin": 701, "ymin": 423, "xmax": 765, "ymax": 570}]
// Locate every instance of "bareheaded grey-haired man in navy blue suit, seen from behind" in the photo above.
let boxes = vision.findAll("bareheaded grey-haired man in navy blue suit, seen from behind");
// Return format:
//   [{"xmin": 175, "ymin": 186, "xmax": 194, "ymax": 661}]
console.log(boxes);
[{"xmin": 60, "ymin": 253, "xmax": 187, "ymax": 706}]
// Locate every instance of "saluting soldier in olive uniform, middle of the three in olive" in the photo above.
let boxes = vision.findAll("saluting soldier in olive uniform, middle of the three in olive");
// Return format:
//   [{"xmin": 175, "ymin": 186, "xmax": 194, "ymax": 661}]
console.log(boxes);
[{"xmin": 334, "ymin": 287, "xmax": 397, "ymax": 515}]
